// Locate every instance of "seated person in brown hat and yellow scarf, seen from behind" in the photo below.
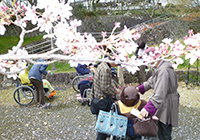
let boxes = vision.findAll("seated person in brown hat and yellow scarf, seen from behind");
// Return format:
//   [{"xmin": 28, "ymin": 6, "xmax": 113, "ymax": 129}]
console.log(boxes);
[{"xmin": 116, "ymin": 86, "xmax": 147, "ymax": 139}]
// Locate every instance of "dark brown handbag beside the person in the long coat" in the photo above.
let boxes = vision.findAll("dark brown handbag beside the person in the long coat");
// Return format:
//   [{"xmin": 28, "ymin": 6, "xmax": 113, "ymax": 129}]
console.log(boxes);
[{"xmin": 133, "ymin": 115, "xmax": 158, "ymax": 137}]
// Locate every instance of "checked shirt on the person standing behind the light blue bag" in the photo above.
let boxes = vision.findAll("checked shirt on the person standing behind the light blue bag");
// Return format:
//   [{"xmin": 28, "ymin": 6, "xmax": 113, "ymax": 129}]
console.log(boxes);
[{"xmin": 93, "ymin": 62, "xmax": 117, "ymax": 98}]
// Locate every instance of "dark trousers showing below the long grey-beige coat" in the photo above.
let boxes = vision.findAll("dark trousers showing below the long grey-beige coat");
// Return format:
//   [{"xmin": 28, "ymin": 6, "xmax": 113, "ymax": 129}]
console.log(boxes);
[{"xmin": 158, "ymin": 121, "xmax": 172, "ymax": 140}]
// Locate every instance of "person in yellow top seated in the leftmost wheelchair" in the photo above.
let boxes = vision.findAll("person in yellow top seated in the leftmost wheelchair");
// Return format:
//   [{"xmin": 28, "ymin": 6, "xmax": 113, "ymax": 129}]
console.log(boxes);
[{"xmin": 19, "ymin": 68, "xmax": 56, "ymax": 99}]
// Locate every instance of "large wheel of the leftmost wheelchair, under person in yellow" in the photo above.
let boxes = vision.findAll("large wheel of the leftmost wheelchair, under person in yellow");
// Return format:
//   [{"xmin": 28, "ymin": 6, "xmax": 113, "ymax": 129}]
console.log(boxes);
[{"xmin": 13, "ymin": 85, "xmax": 34, "ymax": 106}]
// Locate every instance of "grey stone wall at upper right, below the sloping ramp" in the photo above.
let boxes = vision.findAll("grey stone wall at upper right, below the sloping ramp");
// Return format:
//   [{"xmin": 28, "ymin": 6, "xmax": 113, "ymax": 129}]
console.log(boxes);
[{"xmin": 138, "ymin": 19, "xmax": 200, "ymax": 45}]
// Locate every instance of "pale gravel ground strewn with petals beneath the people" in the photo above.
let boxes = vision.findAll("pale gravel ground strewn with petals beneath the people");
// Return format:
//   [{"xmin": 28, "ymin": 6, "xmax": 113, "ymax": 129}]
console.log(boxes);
[{"xmin": 0, "ymin": 82, "xmax": 200, "ymax": 140}]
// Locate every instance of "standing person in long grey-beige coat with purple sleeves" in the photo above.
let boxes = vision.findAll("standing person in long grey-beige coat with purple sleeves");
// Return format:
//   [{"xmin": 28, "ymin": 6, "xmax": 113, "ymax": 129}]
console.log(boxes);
[{"xmin": 136, "ymin": 47, "xmax": 180, "ymax": 140}]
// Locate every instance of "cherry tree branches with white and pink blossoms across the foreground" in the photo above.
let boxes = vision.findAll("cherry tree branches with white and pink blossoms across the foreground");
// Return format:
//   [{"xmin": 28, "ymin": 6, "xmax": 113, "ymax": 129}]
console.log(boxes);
[{"xmin": 0, "ymin": 0, "xmax": 200, "ymax": 78}]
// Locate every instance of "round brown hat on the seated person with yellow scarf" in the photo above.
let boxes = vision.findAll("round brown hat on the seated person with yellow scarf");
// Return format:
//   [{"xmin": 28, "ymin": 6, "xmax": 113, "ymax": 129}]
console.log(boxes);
[{"xmin": 119, "ymin": 86, "xmax": 140, "ymax": 107}]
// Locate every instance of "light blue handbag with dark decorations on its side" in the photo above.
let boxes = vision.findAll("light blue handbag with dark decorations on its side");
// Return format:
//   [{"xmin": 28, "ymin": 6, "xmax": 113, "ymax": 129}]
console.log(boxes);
[{"xmin": 95, "ymin": 103, "xmax": 128, "ymax": 138}]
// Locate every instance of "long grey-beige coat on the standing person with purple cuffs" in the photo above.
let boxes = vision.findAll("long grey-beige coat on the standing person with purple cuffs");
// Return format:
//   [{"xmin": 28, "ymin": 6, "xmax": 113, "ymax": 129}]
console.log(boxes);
[{"xmin": 144, "ymin": 61, "xmax": 180, "ymax": 127}]
